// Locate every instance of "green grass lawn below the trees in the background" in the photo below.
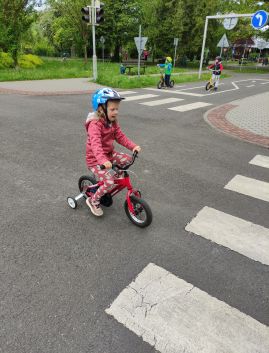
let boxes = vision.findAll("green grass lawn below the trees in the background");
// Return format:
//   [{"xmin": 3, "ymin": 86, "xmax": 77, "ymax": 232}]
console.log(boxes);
[{"xmin": 0, "ymin": 58, "xmax": 228, "ymax": 88}]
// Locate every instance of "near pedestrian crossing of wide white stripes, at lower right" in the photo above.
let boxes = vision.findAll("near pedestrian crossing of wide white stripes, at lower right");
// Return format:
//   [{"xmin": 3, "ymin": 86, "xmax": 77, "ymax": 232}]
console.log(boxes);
[{"xmin": 106, "ymin": 155, "xmax": 269, "ymax": 353}]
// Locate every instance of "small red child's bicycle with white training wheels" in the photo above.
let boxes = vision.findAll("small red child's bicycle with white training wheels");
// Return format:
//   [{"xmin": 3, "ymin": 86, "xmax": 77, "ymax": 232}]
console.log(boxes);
[{"xmin": 67, "ymin": 152, "xmax": 152, "ymax": 228}]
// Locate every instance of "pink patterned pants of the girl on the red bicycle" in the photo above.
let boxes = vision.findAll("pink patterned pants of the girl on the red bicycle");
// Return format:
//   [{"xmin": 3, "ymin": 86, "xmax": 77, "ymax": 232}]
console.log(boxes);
[{"xmin": 91, "ymin": 151, "xmax": 131, "ymax": 202}]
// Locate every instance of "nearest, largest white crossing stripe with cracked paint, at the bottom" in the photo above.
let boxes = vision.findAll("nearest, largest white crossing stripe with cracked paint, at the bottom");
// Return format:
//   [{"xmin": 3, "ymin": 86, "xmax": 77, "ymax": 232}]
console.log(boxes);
[{"xmin": 106, "ymin": 264, "xmax": 269, "ymax": 353}]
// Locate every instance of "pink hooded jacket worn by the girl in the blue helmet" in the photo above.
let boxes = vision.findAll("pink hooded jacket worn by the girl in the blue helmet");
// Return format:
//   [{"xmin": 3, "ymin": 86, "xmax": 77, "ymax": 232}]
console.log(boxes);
[{"xmin": 85, "ymin": 113, "xmax": 136, "ymax": 167}]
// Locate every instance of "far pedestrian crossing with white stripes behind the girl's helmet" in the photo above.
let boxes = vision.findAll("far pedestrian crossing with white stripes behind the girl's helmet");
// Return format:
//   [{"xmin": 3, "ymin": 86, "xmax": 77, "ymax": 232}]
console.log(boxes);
[{"xmin": 120, "ymin": 88, "xmax": 212, "ymax": 112}]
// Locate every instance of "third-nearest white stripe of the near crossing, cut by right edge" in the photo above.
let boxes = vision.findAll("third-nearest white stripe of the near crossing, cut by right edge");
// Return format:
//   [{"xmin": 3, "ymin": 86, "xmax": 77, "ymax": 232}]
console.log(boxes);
[{"xmin": 224, "ymin": 175, "xmax": 269, "ymax": 201}]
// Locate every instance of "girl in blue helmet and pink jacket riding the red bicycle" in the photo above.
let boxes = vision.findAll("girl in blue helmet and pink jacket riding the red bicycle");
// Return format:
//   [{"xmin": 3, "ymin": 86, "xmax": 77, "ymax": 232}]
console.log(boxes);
[{"xmin": 85, "ymin": 87, "xmax": 141, "ymax": 216}]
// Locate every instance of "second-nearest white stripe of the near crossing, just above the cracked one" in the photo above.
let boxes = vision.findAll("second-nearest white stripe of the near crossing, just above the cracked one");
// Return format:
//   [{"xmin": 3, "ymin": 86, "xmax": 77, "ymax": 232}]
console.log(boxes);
[{"xmin": 185, "ymin": 207, "xmax": 269, "ymax": 265}]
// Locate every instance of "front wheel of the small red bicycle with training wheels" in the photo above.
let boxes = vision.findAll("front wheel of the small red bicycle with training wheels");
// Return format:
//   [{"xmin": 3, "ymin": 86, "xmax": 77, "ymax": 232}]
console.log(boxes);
[{"xmin": 124, "ymin": 195, "xmax": 152, "ymax": 228}]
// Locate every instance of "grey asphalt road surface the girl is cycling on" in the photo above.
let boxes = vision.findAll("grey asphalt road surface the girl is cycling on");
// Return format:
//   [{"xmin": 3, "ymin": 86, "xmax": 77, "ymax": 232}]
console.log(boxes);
[{"xmin": 0, "ymin": 71, "xmax": 269, "ymax": 353}]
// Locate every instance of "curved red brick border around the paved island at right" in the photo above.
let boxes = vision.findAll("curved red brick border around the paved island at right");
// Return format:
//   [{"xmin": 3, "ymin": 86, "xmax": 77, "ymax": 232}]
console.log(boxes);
[{"xmin": 204, "ymin": 103, "xmax": 269, "ymax": 148}]
